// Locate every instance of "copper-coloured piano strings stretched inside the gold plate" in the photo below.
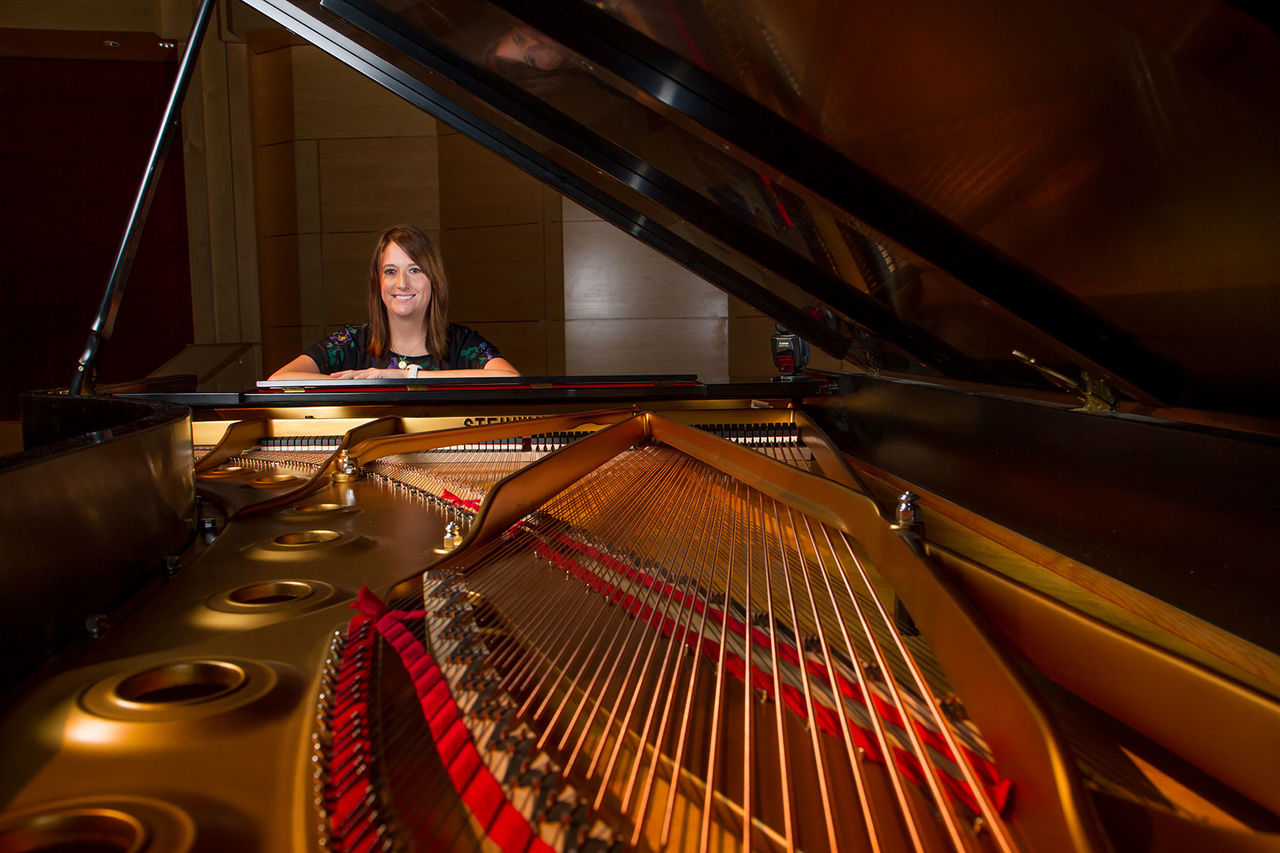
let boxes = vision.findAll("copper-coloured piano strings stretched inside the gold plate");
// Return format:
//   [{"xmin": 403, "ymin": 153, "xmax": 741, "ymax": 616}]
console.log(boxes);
[{"xmin": 332, "ymin": 432, "xmax": 1012, "ymax": 849}]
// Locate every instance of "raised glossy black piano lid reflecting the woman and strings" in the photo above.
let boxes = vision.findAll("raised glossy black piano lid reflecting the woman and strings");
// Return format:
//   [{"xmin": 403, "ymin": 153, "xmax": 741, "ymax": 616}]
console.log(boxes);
[{"xmin": 241, "ymin": 0, "xmax": 1280, "ymax": 414}]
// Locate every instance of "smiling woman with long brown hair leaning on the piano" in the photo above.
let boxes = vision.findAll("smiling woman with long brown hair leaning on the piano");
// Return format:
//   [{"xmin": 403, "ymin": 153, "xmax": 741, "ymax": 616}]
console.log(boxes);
[{"xmin": 270, "ymin": 225, "xmax": 520, "ymax": 379}]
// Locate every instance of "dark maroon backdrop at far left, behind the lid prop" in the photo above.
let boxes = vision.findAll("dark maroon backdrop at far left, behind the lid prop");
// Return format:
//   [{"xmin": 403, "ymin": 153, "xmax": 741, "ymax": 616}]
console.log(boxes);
[{"xmin": 0, "ymin": 58, "xmax": 192, "ymax": 420}]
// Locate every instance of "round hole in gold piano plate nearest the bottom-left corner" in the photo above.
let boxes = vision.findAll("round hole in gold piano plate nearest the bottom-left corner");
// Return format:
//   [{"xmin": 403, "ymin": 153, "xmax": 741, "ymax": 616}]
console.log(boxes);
[{"xmin": 0, "ymin": 808, "xmax": 147, "ymax": 853}]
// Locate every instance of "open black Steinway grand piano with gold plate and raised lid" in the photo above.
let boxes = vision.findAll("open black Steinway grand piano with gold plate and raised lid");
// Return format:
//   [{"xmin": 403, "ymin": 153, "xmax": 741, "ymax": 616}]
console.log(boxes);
[{"xmin": 0, "ymin": 0, "xmax": 1280, "ymax": 853}]
